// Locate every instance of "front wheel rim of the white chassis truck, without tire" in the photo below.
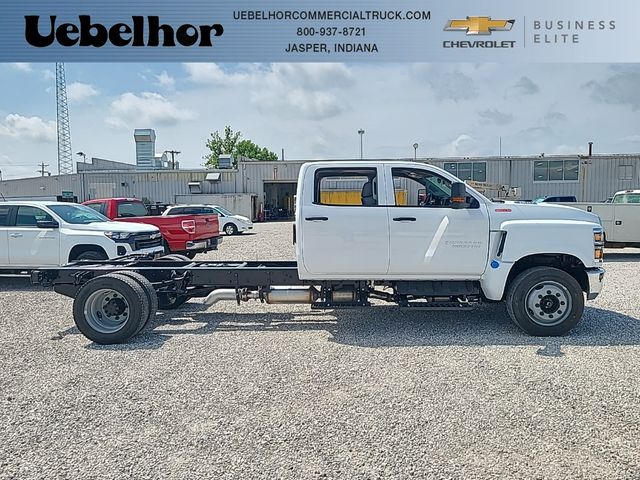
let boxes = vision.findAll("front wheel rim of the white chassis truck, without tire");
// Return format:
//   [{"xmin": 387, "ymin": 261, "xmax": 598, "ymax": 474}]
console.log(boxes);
[{"xmin": 526, "ymin": 281, "xmax": 572, "ymax": 327}]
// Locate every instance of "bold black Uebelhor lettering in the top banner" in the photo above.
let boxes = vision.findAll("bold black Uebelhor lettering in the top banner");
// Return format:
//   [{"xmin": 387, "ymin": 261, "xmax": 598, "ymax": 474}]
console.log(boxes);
[{"xmin": 24, "ymin": 15, "xmax": 224, "ymax": 48}]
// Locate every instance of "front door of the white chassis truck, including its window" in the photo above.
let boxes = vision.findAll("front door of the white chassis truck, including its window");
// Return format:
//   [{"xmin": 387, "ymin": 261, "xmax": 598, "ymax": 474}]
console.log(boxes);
[{"xmin": 385, "ymin": 165, "xmax": 489, "ymax": 280}]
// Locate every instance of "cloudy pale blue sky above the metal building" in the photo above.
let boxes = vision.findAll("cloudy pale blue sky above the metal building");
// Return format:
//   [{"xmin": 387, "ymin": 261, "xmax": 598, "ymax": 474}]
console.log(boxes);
[{"xmin": 0, "ymin": 63, "xmax": 640, "ymax": 178}]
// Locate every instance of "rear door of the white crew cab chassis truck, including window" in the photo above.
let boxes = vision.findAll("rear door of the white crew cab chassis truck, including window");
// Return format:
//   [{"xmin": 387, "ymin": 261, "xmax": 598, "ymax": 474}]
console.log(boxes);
[{"xmin": 297, "ymin": 166, "xmax": 389, "ymax": 278}]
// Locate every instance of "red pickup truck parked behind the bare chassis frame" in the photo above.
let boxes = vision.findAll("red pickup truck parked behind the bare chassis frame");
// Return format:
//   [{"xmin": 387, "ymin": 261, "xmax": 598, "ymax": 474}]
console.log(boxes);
[{"xmin": 83, "ymin": 198, "xmax": 222, "ymax": 258}]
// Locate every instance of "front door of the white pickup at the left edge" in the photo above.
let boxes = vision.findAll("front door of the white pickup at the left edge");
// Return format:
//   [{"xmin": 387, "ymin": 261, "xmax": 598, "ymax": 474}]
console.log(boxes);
[{"xmin": 7, "ymin": 205, "xmax": 60, "ymax": 267}]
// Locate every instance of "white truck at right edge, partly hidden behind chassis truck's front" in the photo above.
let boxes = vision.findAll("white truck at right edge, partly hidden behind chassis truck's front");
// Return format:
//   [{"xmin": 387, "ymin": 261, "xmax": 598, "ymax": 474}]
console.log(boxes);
[{"xmin": 561, "ymin": 190, "xmax": 640, "ymax": 248}]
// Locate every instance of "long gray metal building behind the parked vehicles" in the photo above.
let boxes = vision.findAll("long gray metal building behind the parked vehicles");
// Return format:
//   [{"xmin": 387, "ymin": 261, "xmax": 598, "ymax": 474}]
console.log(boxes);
[{"xmin": 0, "ymin": 154, "xmax": 640, "ymax": 218}]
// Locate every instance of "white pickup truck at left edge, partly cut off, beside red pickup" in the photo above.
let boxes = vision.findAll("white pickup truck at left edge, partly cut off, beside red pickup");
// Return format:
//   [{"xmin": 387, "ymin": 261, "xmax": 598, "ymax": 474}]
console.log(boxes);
[{"xmin": 0, "ymin": 201, "xmax": 164, "ymax": 271}]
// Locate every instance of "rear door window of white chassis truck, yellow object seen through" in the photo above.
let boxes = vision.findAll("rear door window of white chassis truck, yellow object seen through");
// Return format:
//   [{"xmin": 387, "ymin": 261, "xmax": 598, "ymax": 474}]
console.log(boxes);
[{"xmin": 313, "ymin": 168, "xmax": 379, "ymax": 207}]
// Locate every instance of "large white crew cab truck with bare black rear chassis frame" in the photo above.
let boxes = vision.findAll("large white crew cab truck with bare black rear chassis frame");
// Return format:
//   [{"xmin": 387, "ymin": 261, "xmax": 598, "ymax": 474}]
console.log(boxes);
[{"xmin": 32, "ymin": 161, "xmax": 604, "ymax": 343}]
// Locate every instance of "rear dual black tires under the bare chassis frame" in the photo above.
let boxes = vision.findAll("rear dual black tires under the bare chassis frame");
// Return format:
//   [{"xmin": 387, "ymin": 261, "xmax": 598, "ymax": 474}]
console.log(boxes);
[{"xmin": 73, "ymin": 273, "xmax": 150, "ymax": 345}]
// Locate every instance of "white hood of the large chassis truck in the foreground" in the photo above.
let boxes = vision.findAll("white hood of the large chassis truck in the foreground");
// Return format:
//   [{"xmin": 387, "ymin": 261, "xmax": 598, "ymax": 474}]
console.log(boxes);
[{"xmin": 489, "ymin": 203, "xmax": 600, "ymax": 225}]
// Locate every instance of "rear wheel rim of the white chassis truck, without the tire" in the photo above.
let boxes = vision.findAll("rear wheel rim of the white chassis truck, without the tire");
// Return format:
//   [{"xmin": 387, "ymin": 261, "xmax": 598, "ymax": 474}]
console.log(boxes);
[{"xmin": 84, "ymin": 288, "xmax": 131, "ymax": 334}]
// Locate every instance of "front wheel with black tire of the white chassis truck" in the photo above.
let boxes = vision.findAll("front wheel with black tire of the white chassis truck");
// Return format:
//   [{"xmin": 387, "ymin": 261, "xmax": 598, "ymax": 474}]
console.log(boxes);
[{"xmin": 505, "ymin": 267, "xmax": 584, "ymax": 337}]
